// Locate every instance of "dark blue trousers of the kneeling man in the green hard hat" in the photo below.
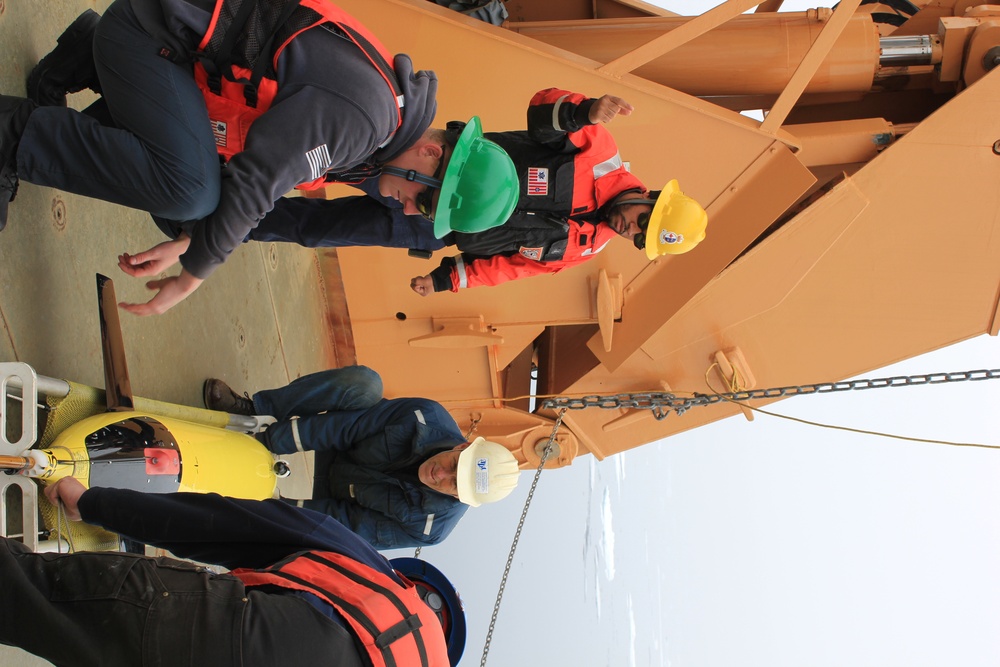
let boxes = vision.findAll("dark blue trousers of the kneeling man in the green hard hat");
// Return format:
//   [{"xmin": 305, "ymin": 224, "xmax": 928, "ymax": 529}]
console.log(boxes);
[{"xmin": 17, "ymin": 0, "xmax": 221, "ymax": 220}]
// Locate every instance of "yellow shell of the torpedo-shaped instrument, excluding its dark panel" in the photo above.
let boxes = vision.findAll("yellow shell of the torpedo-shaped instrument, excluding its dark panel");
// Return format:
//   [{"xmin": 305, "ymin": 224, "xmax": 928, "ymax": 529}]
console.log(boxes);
[{"xmin": 41, "ymin": 411, "xmax": 277, "ymax": 500}]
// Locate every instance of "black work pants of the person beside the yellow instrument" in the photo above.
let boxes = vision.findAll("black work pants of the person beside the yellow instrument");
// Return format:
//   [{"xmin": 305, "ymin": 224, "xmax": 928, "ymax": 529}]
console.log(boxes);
[{"xmin": 0, "ymin": 538, "xmax": 362, "ymax": 667}]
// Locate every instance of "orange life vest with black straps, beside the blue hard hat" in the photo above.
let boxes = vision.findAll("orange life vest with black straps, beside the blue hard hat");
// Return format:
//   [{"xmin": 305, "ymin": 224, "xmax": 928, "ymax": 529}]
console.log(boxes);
[{"xmin": 231, "ymin": 551, "xmax": 450, "ymax": 667}]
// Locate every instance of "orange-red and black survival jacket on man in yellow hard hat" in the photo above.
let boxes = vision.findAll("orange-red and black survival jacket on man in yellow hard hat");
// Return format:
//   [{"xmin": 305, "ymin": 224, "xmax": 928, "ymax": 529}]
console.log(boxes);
[{"xmin": 431, "ymin": 88, "xmax": 646, "ymax": 292}]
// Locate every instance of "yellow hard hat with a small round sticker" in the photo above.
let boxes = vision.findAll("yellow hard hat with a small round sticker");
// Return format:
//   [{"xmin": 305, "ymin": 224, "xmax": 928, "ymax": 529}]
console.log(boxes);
[{"xmin": 645, "ymin": 179, "xmax": 708, "ymax": 259}]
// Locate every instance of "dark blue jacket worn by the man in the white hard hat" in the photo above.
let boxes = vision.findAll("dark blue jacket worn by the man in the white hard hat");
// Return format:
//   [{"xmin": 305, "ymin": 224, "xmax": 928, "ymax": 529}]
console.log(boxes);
[{"xmin": 266, "ymin": 398, "xmax": 467, "ymax": 549}]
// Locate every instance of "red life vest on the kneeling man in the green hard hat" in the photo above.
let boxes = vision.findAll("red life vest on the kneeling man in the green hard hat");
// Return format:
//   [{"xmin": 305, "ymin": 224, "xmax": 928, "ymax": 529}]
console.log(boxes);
[{"xmin": 194, "ymin": 0, "xmax": 403, "ymax": 190}]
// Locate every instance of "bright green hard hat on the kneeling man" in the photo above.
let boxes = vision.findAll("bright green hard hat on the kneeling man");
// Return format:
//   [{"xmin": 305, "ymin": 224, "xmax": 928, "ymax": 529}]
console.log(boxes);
[{"xmin": 434, "ymin": 116, "xmax": 520, "ymax": 238}]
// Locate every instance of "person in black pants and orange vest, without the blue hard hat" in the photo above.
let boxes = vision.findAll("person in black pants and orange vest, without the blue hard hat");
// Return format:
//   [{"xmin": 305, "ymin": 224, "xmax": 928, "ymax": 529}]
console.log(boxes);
[{"xmin": 0, "ymin": 477, "xmax": 454, "ymax": 667}]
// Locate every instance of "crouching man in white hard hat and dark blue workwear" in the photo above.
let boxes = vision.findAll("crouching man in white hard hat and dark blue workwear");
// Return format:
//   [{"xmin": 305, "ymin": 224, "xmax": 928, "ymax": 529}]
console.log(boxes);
[{"xmin": 204, "ymin": 366, "xmax": 520, "ymax": 549}]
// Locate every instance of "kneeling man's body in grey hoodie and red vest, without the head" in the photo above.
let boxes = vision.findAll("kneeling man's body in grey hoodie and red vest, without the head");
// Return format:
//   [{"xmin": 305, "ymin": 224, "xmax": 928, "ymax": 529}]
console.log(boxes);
[{"xmin": 0, "ymin": 0, "xmax": 437, "ymax": 315}]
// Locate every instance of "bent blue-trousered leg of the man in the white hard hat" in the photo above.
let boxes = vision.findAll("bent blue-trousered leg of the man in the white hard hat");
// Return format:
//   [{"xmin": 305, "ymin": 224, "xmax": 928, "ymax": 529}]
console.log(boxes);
[{"xmin": 253, "ymin": 366, "xmax": 382, "ymax": 421}]
